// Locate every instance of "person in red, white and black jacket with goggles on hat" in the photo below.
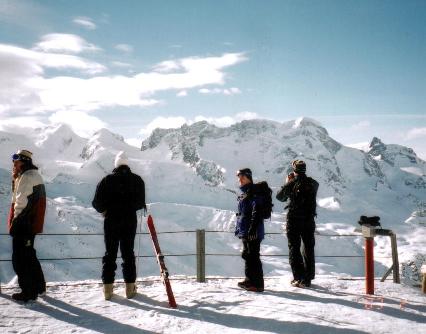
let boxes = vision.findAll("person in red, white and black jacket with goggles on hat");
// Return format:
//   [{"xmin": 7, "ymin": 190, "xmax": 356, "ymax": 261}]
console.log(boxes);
[{"xmin": 8, "ymin": 150, "xmax": 46, "ymax": 302}]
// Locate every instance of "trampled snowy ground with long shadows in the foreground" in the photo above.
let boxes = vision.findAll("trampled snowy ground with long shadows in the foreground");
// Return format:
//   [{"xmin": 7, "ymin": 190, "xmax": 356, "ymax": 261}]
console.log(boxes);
[{"xmin": 0, "ymin": 275, "xmax": 426, "ymax": 334}]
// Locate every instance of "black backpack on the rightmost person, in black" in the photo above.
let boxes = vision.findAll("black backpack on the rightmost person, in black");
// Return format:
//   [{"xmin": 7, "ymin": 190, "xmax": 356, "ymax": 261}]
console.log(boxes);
[{"xmin": 288, "ymin": 177, "xmax": 319, "ymax": 216}]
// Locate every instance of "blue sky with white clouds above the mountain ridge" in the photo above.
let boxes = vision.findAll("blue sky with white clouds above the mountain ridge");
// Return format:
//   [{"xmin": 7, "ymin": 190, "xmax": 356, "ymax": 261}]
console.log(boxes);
[{"xmin": 0, "ymin": 0, "xmax": 426, "ymax": 158}]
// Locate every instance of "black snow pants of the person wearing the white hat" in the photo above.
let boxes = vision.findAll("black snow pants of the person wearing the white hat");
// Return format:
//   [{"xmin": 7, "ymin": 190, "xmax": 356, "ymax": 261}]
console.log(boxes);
[{"xmin": 102, "ymin": 213, "xmax": 137, "ymax": 284}]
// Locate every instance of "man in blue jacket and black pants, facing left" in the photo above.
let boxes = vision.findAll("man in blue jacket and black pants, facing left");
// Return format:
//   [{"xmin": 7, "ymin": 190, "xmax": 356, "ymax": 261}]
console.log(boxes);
[{"xmin": 235, "ymin": 168, "xmax": 265, "ymax": 292}]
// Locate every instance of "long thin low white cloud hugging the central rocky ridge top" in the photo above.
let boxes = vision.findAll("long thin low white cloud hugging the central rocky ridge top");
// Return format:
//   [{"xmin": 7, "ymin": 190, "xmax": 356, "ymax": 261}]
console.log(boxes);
[{"xmin": 139, "ymin": 112, "xmax": 259, "ymax": 138}]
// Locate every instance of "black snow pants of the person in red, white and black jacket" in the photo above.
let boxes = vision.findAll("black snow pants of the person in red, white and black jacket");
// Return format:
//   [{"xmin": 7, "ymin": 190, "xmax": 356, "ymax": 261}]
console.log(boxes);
[{"xmin": 12, "ymin": 235, "xmax": 46, "ymax": 299}]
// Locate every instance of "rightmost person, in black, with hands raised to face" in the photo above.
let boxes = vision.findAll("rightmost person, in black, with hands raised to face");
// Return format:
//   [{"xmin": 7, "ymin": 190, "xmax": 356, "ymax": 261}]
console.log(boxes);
[{"xmin": 276, "ymin": 160, "xmax": 318, "ymax": 287}]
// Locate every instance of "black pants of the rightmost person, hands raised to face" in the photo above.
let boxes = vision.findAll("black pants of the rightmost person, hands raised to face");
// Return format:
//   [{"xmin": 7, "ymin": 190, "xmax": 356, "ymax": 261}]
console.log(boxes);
[{"xmin": 287, "ymin": 218, "xmax": 315, "ymax": 281}]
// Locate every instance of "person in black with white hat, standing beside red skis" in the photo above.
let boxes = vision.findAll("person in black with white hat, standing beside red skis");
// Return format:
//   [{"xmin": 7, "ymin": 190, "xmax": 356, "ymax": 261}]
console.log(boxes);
[{"xmin": 92, "ymin": 152, "xmax": 146, "ymax": 300}]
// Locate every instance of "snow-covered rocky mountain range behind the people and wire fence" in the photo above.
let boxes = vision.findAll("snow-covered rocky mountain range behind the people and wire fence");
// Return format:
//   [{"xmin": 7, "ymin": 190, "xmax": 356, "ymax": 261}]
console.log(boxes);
[{"xmin": 0, "ymin": 118, "xmax": 426, "ymax": 280}]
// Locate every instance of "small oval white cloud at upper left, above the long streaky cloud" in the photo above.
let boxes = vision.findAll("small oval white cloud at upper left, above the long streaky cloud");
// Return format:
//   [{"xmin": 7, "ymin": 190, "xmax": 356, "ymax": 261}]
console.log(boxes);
[{"xmin": 34, "ymin": 34, "xmax": 101, "ymax": 53}]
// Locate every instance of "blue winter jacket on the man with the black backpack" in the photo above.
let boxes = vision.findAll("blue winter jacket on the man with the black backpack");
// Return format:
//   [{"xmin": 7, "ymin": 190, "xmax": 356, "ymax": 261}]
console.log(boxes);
[{"xmin": 235, "ymin": 183, "xmax": 265, "ymax": 240}]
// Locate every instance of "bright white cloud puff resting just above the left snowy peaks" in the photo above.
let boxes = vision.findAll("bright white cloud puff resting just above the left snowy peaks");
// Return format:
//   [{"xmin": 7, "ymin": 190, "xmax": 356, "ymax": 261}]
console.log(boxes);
[{"xmin": 49, "ymin": 111, "xmax": 107, "ymax": 138}]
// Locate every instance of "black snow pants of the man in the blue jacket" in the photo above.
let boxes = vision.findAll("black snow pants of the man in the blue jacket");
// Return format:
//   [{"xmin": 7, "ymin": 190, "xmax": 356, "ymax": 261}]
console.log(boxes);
[{"xmin": 241, "ymin": 239, "xmax": 264, "ymax": 288}]
